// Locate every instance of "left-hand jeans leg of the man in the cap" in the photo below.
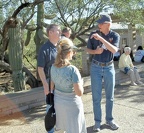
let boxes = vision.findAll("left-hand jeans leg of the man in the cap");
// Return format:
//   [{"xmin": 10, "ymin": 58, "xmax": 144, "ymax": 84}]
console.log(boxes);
[{"xmin": 90, "ymin": 63, "xmax": 102, "ymax": 128}]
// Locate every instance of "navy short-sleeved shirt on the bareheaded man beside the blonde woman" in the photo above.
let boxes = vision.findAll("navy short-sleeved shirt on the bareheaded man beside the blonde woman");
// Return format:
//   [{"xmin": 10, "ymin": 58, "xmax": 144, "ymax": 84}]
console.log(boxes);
[{"xmin": 37, "ymin": 41, "xmax": 57, "ymax": 78}]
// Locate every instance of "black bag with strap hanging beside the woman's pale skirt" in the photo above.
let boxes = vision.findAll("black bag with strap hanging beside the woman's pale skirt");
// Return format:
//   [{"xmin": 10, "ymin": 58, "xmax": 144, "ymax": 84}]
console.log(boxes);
[{"xmin": 44, "ymin": 67, "xmax": 56, "ymax": 131}]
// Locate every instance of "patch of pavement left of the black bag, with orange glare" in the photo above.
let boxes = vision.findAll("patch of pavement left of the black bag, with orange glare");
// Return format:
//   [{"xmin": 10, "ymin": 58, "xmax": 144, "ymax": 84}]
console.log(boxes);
[{"xmin": 0, "ymin": 106, "xmax": 46, "ymax": 133}]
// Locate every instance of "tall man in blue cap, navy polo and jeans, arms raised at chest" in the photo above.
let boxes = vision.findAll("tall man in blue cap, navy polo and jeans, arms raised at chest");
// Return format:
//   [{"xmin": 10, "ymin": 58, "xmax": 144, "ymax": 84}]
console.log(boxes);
[{"xmin": 87, "ymin": 15, "xmax": 120, "ymax": 131}]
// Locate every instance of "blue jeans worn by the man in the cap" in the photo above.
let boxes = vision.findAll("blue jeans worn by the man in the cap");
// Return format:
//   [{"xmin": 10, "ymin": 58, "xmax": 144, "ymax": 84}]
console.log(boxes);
[{"xmin": 90, "ymin": 63, "xmax": 115, "ymax": 124}]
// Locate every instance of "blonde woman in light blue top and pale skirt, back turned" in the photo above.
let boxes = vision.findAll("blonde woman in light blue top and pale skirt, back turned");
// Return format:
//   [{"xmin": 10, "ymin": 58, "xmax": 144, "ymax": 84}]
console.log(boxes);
[{"xmin": 51, "ymin": 38, "xmax": 87, "ymax": 133}]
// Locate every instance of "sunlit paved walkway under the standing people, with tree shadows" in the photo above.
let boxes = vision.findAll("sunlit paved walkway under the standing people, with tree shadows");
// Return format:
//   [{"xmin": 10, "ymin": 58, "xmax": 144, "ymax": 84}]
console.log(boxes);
[{"xmin": 0, "ymin": 78, "xmax": 144, "ymax": 133}]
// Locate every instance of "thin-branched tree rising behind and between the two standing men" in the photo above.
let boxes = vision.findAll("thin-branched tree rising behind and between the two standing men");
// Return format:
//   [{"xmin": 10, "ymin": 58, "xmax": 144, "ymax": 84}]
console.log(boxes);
[{"xmin": 47, "ymin": 0, "xmax": 108, "ymax": 45}]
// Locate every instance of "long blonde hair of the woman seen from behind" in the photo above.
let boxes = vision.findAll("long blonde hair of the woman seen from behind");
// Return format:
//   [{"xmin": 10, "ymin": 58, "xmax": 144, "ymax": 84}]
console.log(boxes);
[{"xmin": 54, "ymin": 37, "xmax": 75, "ymax": 67}]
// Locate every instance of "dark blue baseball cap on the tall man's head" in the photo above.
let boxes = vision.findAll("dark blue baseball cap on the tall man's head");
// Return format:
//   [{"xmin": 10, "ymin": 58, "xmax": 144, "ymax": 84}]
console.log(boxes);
[{"xmin": 96, "ymin": 15, "xmax": 112, "ymax": 24}]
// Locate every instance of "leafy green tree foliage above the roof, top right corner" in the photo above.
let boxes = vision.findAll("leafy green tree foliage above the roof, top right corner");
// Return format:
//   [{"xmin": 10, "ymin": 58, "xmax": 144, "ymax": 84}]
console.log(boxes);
[{"xmin": 111, "ymin": 0, "xmax": 144, "ymax": 25}]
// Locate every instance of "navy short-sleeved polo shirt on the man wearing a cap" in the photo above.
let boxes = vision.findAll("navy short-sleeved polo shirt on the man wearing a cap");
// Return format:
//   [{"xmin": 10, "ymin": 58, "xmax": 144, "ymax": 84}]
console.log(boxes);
[{"xmin": 87, "ymin": 30, "xmax": 120, "ymax": 63}]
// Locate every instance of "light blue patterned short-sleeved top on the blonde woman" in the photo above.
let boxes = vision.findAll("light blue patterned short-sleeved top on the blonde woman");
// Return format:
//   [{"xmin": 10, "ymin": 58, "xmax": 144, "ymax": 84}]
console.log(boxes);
[{"xmin": 51, "ymin": 65, "xmax": 81, "ymax": 93}]
